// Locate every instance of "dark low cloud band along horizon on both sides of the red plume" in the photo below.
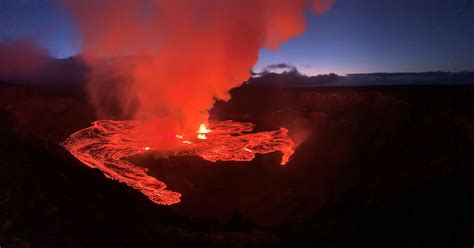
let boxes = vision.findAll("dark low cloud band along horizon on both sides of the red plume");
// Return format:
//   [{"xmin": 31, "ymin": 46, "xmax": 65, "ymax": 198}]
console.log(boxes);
[{"xmin": 0, "ymin": 54, "xmax": 474, "ymax": 87}]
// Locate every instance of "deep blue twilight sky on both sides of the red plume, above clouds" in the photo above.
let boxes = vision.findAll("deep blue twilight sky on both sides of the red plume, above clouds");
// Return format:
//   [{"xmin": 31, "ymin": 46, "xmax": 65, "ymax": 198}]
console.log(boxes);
[{"xmin": 0, "ymin": 0, "xmax": 474, "ymax": 74}]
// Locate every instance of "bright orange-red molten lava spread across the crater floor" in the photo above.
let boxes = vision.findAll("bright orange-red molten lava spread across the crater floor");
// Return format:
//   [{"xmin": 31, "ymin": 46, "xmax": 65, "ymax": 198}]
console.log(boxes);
[{"xmin": 62, "ymin": 120, "xmax": 294, "ymax": 205}]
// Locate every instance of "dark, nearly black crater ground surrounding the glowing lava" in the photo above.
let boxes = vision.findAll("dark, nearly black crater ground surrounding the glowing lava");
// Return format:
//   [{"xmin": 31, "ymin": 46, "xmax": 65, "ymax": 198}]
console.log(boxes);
[{"xmin": 0, "ymin": 84, "xmax": 474, "ymax": 248}]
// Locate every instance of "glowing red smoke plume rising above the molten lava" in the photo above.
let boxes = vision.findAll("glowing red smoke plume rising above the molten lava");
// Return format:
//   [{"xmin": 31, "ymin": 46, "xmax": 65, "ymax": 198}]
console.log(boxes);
[{"xmin": 68, "ymin": 0, "xmax": 332, "ymax": 132}]
